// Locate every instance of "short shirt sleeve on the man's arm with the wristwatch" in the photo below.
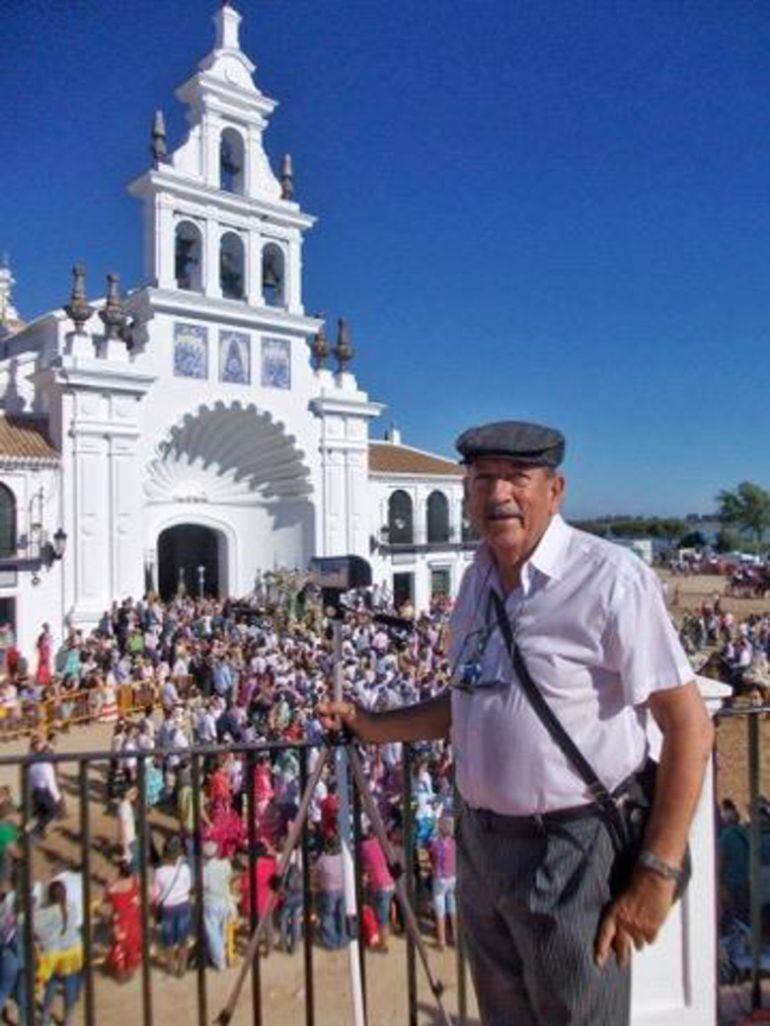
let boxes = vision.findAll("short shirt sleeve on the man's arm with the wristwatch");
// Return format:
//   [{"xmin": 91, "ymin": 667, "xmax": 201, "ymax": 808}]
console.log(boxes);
[{"xmin": 604, "ymin": 563, "xmax": 695, "ymax": 705}]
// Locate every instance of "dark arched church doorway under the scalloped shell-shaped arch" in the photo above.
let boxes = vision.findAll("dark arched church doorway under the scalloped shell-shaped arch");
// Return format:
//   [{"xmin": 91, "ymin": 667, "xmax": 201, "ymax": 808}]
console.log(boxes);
[{"xmin": 158, "ymin": 523, "xmax": 227, "ymax": 600}]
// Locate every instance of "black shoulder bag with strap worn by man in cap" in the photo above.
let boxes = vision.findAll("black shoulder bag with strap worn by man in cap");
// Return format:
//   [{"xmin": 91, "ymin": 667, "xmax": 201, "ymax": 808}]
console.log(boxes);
[{"xmin": 491, "ymin": 588, "xmax": 692, "ymax": 900}]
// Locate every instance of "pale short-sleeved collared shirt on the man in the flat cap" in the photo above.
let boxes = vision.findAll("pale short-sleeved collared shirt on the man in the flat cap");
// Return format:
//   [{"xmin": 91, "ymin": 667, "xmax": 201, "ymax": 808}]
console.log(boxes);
[{"xmin": 450, "ymin": 515, "xmax": 693, "ymax": 816}]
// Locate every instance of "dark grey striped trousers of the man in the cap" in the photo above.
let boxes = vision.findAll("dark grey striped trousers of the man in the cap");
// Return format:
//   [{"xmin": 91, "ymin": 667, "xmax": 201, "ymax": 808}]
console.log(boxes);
[{"xmin": 457, "ymin": 803, "xmax": 630, "ymax": 1026}]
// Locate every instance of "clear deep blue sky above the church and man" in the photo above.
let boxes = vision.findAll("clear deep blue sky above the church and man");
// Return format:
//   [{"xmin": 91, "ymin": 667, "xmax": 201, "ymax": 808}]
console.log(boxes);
[{"xmin": 0, "ymin": 0, "xmax": 770, "ymax": 515}]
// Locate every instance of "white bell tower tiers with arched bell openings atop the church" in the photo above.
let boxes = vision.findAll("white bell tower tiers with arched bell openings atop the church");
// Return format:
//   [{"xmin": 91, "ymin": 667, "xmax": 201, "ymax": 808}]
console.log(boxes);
[{"xmin": 129, "ymin": 3, "xmax": 315, "ymax": 317}]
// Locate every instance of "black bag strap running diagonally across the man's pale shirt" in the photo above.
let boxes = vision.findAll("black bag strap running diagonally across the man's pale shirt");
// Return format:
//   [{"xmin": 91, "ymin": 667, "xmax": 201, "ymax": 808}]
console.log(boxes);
[{"xmin": 490, "ymin": 588, "xmax": 626, "ymax": 845}]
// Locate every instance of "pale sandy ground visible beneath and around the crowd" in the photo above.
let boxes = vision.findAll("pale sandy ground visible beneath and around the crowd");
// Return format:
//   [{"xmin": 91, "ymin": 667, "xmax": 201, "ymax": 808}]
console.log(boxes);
[{"xmin": 0, "ymin": 577, "xmax": 770, "ymax": 1026}]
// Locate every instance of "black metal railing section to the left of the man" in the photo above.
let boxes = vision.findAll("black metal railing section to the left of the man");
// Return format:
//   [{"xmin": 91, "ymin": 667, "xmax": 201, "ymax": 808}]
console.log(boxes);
[{"xmin": 0, "ymin": 743, "xmax": 468, "ymax": 1026}]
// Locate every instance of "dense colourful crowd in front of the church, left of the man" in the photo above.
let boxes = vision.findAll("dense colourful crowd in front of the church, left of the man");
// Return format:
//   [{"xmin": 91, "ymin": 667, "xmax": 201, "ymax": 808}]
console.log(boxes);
[{"xmin": 0, "ymin": 594, "xmax": 456, "ymax": 1022}]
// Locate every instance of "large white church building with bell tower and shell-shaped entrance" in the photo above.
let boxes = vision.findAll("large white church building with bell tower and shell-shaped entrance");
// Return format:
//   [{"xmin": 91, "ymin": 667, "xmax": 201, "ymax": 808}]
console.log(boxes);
[{"xmin": 0, "ymin": 4, "xmax": 473, "ymax": 650}]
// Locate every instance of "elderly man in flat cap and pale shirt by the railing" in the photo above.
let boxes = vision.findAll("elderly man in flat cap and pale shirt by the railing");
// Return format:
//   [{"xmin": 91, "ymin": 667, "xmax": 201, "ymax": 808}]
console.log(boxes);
[{"xmin": 321, "ymin": 422, "xmax": 713, "ymax": 1026}]
